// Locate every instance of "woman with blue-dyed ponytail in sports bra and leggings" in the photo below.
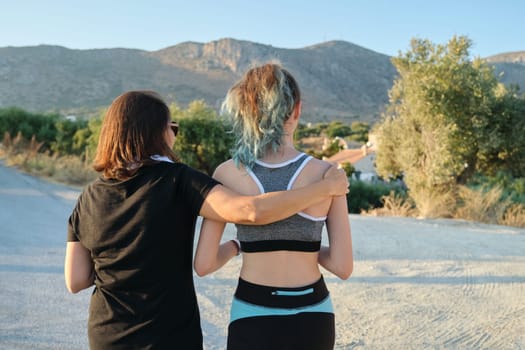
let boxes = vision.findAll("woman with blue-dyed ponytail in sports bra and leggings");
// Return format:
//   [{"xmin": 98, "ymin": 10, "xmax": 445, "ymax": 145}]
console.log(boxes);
[{"xmin": 194, "ymin": 64, "xmax": 353, "ymax": 350}]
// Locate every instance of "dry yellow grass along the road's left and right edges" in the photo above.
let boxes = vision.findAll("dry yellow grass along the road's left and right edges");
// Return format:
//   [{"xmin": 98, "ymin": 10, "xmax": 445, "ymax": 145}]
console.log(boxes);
[{"xmin": 0, "ymin": 133, "xmax": 525, "ymax": 227}]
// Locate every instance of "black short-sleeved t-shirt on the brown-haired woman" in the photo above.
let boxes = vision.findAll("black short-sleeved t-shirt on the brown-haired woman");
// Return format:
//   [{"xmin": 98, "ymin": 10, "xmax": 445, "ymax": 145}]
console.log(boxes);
[{"xmin": 68, "ymin": 162, "xmax": 218, "ymax": 349}]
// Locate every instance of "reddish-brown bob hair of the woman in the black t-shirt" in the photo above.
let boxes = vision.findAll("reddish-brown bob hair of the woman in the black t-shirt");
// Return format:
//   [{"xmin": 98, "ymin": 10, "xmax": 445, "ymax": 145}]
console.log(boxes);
[{"xmin": 93, "ymin": 91, "xmax": 177, "ymax": 180}]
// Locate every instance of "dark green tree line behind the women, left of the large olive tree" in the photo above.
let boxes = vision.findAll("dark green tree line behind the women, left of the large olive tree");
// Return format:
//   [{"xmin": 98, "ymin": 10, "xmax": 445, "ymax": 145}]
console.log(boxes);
[{"xmin": 0, "ymin": 100, "xmax": 370, "ymax": 175}]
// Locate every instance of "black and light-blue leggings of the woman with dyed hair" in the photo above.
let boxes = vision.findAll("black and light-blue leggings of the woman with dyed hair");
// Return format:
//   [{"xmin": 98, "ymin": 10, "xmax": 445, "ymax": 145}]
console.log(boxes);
[{"xmin": 227, "ymin": 277, "xmax": 335, "ymax": 350}]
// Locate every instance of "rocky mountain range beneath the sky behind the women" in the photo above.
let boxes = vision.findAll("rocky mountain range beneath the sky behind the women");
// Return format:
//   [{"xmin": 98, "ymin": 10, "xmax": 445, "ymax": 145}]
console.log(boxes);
[{"xmin": 0, "ymin": 39, "xmax": 525, "ymax": 122}]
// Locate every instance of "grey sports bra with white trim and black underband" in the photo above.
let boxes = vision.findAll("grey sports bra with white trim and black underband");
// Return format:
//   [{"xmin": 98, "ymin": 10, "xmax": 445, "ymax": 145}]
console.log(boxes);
[{"xmin": 236, "ymin": 153, "xmax": 326, "ymax": 253}]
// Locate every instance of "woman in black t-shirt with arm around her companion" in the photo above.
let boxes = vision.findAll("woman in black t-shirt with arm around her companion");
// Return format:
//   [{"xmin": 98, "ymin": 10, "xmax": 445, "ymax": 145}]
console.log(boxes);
[{"xmin": 64, "ymin": 91, "xmax": 348, "ymax": 350}]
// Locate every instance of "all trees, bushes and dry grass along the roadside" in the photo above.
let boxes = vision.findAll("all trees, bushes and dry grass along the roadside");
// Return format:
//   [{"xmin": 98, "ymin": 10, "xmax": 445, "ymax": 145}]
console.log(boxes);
[{"xmin": 0, "ymin": 37, "xmax": 525, "ymax": 227}]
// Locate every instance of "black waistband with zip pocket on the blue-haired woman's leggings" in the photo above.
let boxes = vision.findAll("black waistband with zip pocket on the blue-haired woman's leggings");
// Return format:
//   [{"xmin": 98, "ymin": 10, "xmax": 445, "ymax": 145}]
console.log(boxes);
[{"xmin": 235, "ymin": 276, "xmax": 329, "ymax": 308}]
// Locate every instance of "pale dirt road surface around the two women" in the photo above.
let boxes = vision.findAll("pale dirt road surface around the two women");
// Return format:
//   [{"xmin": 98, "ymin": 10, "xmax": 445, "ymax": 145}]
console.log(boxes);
[{"xmin": 0, "ymin": 165, "xmax": 525, "ymax": 350}]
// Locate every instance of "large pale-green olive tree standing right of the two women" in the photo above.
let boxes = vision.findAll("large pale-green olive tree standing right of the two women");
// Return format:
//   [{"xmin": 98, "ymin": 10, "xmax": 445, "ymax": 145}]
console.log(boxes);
[{"xmin": 375, "ymin": 37, "xmax": 498, "ymax": 216}]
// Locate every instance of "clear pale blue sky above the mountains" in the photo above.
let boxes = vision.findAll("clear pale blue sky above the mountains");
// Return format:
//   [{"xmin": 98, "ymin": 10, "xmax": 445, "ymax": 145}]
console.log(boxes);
[{"xmin": 0, "ymin": 0, "xmax": 525, "ymax": 57}]
